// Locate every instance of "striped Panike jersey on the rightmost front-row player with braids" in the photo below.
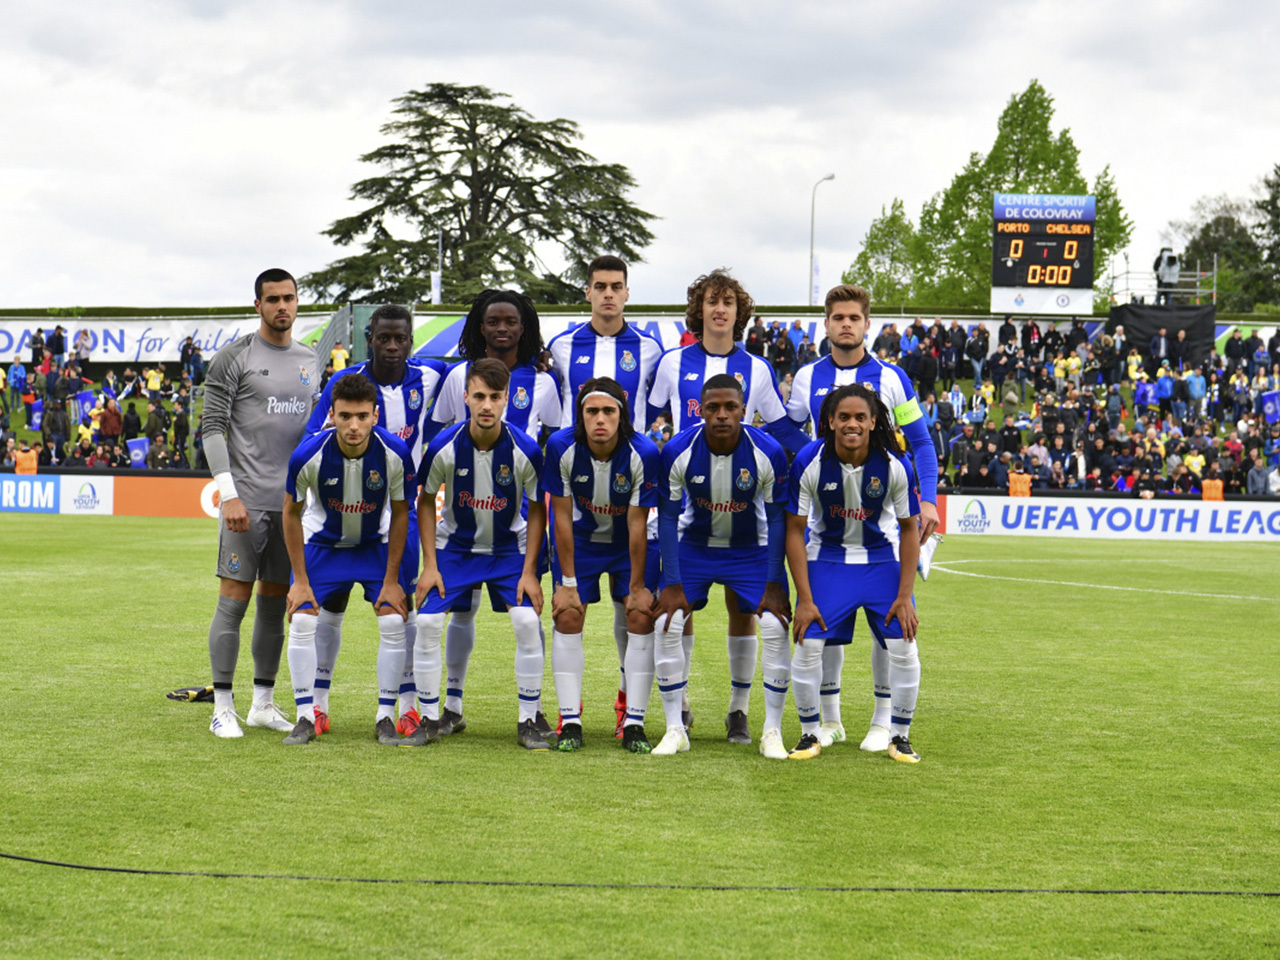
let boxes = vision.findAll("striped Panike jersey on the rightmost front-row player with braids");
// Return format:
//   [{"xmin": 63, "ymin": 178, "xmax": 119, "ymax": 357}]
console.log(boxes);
[{"xmin": 787, "ymin": 440, "xmax": 920, "ymax": 563}]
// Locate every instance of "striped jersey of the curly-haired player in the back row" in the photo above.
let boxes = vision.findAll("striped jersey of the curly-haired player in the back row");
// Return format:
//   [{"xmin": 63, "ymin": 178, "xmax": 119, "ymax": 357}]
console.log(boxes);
[{"xmin": 649, "ymin": 343, "xmax": 787, "ymax": 433}]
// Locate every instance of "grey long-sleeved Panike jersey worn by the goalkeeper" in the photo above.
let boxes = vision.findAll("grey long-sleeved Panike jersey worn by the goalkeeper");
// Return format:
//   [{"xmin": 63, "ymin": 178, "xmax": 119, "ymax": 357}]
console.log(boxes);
[{"xmin": 204, "ymin": 332, "xmax": 320, "ymax": 511}]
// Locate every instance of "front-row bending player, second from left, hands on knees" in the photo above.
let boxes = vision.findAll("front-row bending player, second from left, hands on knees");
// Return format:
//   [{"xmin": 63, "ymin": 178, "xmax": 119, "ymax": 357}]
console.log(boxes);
[{"xmin": 406, "ymin": 357, "xmax": 550, "ymax": 750}]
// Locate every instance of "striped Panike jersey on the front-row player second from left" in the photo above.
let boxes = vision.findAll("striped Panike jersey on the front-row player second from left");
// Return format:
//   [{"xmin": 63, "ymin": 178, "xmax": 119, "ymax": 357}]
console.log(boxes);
[{"xmin": 421, "ymin": 421, "xmax": 543, "ymax": 557}]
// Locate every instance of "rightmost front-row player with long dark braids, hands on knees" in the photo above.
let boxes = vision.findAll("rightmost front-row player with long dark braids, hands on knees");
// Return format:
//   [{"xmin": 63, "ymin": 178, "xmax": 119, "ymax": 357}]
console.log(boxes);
[{"xmin": 786, "ymin": 384, "xmax": 920, "ymax": 763}]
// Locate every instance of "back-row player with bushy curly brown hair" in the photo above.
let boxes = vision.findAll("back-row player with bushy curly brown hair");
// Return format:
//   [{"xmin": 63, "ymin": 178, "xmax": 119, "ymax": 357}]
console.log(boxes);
[{"xmin": 648, "ymin": 270, "xmax": 809, "ymax": 744}]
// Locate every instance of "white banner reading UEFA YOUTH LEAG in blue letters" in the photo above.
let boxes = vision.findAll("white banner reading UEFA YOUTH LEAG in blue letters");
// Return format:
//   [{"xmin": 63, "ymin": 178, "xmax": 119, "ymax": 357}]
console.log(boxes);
[{"xmin": 938, "ymin": 494, "xmax": 1280, "ymax": 543}]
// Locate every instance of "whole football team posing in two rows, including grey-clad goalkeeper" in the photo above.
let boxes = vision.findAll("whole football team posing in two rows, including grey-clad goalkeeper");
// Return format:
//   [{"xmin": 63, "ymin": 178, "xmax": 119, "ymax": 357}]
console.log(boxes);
[{"xmin": 204, "ymin": 256, "xmax": 941, "ymax": 763}]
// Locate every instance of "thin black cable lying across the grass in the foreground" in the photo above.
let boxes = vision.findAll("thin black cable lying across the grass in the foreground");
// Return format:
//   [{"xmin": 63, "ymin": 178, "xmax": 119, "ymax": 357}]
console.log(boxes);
[{"xmin": 0, "ymin": 852, "xmax": 1280, "ymax": 897}]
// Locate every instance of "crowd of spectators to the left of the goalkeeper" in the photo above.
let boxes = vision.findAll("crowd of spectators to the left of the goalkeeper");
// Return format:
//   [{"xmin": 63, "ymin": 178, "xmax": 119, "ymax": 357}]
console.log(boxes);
[{"xmin": 0, "ymin": 326, "xmax": 205, "ymax": 472}]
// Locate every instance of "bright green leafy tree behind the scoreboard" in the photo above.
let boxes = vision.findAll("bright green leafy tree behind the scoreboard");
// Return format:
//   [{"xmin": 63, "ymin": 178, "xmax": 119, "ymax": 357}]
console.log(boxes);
[{"xmin": 854, "ymin": 81, "xmax": 1133, "ymax": 307}]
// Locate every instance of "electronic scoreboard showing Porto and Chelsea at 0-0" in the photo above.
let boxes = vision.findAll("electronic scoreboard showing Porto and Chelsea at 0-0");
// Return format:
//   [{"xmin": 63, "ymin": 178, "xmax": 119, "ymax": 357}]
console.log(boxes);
[{"xmin": 991, "ymin": 193, "xmax": 1096, "ymax": 314}]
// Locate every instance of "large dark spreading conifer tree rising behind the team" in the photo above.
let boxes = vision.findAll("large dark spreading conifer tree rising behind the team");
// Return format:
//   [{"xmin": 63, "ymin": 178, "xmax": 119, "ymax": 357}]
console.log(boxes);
[{"xmin": 302, "ymin": 83, "xmax": 654, "ymax": 303}]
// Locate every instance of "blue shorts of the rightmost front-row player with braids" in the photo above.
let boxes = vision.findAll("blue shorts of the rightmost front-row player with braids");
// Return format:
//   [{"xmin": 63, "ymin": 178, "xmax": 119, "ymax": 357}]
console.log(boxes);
[{"xmin": 805, "ymin": 561, "xmax": 915, "ymax": 646}]
